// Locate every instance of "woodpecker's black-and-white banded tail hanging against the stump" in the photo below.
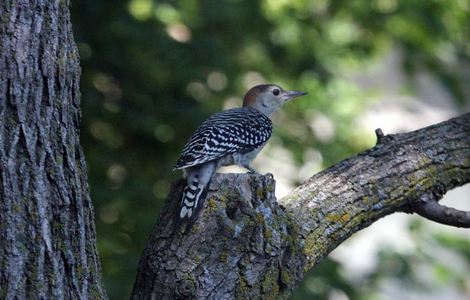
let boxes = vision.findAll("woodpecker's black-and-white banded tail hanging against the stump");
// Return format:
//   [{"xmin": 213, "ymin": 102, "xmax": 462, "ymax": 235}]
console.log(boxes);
[{"xmin": 177, "ymin": 174, "xmax": 208, "ymax": 232}]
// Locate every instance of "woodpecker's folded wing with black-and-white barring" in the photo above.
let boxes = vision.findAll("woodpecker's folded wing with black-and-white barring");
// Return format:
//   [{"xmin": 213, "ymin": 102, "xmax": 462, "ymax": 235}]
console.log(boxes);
[{"xmin": 174, "ymin": 107, "xmax": 272, "ymax": 169}]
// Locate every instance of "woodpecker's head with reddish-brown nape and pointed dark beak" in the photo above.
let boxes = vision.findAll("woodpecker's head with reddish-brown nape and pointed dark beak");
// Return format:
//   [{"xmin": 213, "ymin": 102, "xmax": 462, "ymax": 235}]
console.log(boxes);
[{"xmin": 243, "ymin": 84, "xmax": 307, "ymax": 117}]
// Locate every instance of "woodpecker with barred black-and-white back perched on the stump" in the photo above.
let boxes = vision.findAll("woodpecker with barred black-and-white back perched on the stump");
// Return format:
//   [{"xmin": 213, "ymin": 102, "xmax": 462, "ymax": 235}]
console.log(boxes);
[{"xmin": 174, "ymin": 84, "xmax": 307, "ymax": 230}]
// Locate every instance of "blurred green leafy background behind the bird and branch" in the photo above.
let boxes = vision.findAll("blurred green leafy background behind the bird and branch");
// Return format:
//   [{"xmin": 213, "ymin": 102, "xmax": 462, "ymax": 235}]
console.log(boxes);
[{"xmin": 72, "ymin": 0, "xmax": 470, "ymax": 299}]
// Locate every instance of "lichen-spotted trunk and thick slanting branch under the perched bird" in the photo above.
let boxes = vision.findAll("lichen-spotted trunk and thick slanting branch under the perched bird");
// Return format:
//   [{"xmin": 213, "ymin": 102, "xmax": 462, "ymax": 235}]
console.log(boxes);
[{"xmin": 132, "ymin": 114, "xmax": 470, "ymax": 299}]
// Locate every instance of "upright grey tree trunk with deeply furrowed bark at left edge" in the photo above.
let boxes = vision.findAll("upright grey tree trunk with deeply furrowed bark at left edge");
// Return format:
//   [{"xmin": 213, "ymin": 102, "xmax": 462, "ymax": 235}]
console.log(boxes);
[{"xmin": 0, "ymin": 0, "xmax": 106, "ymax": 299}]
